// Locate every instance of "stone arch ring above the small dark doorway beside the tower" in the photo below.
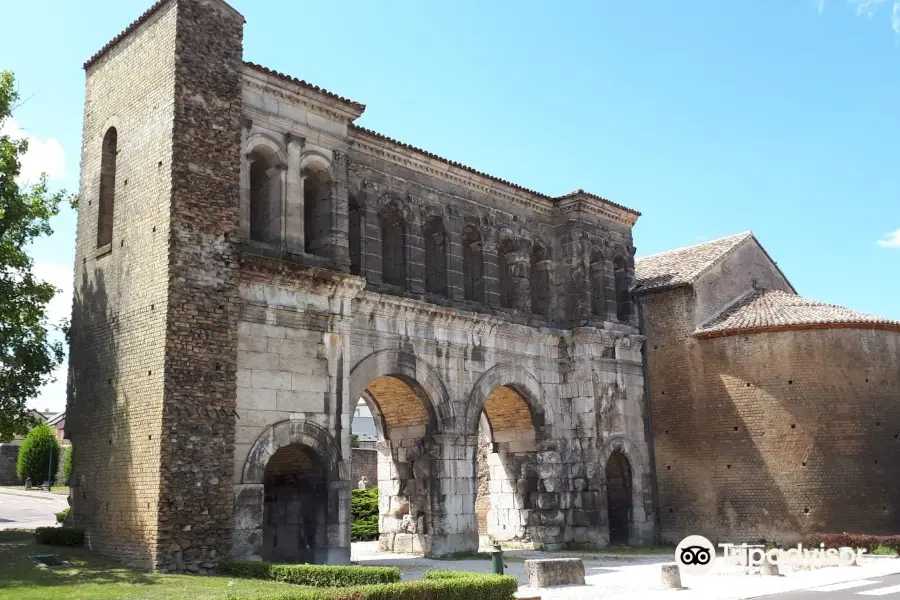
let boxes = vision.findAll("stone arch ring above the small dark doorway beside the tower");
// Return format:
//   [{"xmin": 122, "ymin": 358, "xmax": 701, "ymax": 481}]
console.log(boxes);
[{"xmin": 241, "ymin": 420, "xmax": 342, "ymax": 484}]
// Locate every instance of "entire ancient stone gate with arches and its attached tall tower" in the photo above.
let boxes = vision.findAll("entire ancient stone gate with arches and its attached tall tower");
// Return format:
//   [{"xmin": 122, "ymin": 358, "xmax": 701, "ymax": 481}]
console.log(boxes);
[{"xmin": 67, "ymin": 0, "xmax": 655, "ymax": 571}]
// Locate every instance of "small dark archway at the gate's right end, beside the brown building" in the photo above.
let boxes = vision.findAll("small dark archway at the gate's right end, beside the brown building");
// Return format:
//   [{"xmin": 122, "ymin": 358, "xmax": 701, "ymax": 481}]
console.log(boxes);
[{"xmin": 598, "ymin": 436, "xmax": 653, "ymax": 546}]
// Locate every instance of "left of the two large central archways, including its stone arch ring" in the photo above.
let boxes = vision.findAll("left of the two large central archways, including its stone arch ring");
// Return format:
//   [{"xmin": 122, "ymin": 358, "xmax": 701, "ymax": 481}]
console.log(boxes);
[{"xmin": 349, "ymin": 350, "xmax": 455, "ymax": 554}]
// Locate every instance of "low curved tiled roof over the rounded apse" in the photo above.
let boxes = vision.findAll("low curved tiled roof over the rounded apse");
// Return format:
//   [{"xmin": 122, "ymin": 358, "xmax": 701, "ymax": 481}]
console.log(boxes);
[{"xmin": 694, "ymin": 289, "xmax": 900, "ymax": 338}]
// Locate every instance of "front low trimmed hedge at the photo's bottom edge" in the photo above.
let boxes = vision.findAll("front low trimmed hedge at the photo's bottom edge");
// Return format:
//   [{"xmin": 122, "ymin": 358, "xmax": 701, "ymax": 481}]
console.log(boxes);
[{"xmin": 232, "ymin": 567, "xmax": 519, "ymax": 600}]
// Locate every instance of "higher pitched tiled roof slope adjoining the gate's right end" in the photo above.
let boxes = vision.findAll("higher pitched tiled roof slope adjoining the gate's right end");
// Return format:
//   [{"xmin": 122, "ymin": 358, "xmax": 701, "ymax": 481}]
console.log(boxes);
[{"xmin": 634, "ymin": 231, "xmax": 760, "ymax": 292}]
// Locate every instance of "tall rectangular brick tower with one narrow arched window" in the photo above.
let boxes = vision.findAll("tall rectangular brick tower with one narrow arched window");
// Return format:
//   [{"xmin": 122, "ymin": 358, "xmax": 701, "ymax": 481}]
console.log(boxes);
[{"xmin": 67, "ymin": 0, "xmax": 244, "ymax": 570}]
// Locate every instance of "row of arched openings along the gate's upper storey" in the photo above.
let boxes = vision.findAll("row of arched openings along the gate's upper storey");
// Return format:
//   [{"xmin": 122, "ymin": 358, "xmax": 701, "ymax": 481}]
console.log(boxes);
[{"xmin": 243, "ymin": 134, "xmax": 632, "ymax": 322}]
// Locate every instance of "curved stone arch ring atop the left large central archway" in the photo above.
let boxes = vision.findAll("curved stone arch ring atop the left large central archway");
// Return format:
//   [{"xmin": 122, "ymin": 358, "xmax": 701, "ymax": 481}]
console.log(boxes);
[{"xmin": 350, "ymin": 349, "xmax": 456, "ymax": 433}]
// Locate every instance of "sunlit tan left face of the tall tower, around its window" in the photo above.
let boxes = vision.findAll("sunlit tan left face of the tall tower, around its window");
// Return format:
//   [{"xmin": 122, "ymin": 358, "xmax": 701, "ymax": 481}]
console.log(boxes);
[{"xmin": 66, "ymin": 3, "xmax": 177, "ymax": 567}]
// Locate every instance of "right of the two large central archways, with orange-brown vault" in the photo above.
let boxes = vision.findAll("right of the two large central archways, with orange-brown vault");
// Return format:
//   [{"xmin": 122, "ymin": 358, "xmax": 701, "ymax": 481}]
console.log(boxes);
[{"xmin": 466, "ymin": 365, "xmax": 544, "ymax": 544}]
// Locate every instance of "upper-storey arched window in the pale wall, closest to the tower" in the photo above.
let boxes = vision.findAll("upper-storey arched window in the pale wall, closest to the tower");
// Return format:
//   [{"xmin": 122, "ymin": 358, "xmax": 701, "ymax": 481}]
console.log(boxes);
[{"xmin": 250, "ymin": 146, "xmax": 281, "ymax": 244}]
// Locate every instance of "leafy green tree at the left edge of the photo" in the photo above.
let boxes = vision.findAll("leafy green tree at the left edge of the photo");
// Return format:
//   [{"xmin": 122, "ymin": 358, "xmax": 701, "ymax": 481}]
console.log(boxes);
[{"xmin": 0, "ymin": 71, "xmax": 66, "ymax": 441}]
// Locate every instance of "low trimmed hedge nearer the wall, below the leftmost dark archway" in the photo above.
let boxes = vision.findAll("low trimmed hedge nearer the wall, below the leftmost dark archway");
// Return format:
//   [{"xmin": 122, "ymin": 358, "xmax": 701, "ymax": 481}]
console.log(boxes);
[{"xmin": 218, "ymin": 560, "xmax": 400, "ymax": 588}]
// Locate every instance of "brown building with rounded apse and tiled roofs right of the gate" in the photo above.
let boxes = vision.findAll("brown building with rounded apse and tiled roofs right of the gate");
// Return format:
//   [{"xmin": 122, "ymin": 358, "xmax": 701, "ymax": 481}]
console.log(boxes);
[{"xmin": 635, "ymin": 232, "xmax": 900, "ymax": 545}]
